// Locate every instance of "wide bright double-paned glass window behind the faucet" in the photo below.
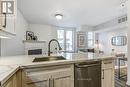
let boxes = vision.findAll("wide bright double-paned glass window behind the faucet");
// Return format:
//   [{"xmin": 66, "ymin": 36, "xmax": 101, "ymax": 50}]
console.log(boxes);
[{"xmin": 57, "ymin": 29, "xmax": 75, "ymax": 51}]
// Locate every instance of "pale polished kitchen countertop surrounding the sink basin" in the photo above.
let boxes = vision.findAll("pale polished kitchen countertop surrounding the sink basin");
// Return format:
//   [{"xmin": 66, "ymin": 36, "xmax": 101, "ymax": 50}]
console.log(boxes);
[{"xmin": 0, "ymin": 53, "xmax": 114, "ymax": 86}]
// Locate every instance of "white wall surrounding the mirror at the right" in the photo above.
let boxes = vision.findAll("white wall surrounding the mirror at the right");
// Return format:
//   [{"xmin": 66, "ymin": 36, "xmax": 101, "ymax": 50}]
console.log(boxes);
[{"xmin": 98, "ymin": 28, "xmax": 127, "ymax": 54}]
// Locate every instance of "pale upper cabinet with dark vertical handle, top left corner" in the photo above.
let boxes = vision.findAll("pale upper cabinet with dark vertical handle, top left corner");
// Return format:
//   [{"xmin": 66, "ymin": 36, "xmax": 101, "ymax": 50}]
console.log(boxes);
[{"xmin": 0, "ymin": 0, "xmax": 17, "ymax": 38}]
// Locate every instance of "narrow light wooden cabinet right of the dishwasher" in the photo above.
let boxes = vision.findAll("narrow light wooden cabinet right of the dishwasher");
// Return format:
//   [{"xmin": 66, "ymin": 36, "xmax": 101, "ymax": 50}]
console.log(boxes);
[{"xmin": 102, "ymin": 60, "xmax": 114, "ymax": 87}]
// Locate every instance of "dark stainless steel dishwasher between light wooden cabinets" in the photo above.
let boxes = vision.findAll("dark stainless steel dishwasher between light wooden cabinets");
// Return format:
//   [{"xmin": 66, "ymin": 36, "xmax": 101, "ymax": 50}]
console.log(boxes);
[{"xmin": 75, "ymin": 60, "xmax": 101, "ymax": 87}]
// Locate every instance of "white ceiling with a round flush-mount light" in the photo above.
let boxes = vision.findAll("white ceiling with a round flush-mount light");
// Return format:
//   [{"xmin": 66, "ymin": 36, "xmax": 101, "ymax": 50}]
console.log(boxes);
[{"xmin": 18, "ymin": 0, "xmax": 126, "ymax": 27}]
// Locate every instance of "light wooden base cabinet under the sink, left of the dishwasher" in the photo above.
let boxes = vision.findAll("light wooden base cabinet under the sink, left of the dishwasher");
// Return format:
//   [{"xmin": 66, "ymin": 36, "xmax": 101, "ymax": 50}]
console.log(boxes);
[{"xmin": 22, "ymin": 65, "xmax": 74, "ymax": 87}]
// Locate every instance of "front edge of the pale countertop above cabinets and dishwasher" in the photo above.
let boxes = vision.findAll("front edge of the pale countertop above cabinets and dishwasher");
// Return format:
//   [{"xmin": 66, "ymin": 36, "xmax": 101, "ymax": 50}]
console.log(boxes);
[{"xmin": 0, "ymin": 57, "xmax": 116, "ymax": 87}]
